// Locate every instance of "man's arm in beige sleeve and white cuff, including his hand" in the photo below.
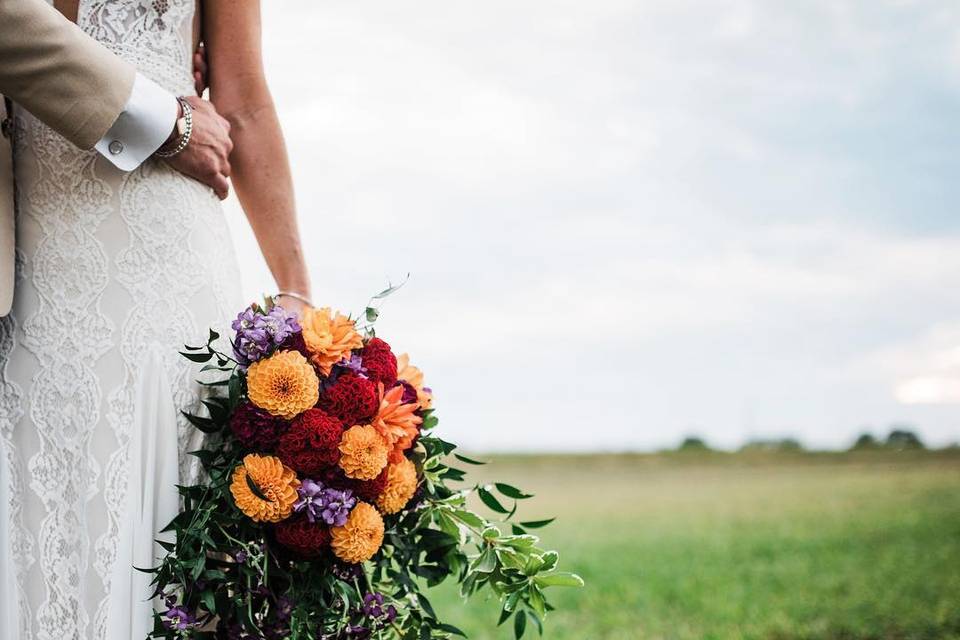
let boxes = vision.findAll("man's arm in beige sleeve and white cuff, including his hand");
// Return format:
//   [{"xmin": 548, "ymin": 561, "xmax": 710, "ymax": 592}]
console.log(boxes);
[{"xmin": 0, "ymin": 0, "xmax": 232, "ymax": 198}]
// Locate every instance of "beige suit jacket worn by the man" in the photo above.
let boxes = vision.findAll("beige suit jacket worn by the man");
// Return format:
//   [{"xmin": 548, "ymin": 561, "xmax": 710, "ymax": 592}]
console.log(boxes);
[{"xmin": 0, "ymin": 0, "xmax": 136, "ymax": 316}]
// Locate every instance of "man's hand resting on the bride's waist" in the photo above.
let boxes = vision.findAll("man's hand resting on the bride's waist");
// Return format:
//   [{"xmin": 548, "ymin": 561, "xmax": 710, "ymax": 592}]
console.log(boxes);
[{"xmin": 164, "ymin": 96, "xmax": 233, "ymax": 200}]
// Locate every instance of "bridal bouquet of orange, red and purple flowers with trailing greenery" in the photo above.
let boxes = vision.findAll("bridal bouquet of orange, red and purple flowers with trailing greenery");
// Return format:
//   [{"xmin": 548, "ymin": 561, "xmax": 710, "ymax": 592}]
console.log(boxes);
[{"xmin": 149, "ymin": 288, "xmax": 582, "ymax": 640}]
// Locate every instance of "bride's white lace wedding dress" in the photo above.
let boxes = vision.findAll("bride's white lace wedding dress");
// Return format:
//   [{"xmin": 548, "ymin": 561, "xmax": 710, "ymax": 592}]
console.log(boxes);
[{"xmin": 0, "ymin": 0, "xmax": 240, "ymax": 640}]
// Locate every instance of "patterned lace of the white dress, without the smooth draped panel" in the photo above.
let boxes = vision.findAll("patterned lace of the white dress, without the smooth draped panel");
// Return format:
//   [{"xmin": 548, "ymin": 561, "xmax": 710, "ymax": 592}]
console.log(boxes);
[{"xmin": 0, "ymin": 0, "xmax": 246, "ymax": 640}]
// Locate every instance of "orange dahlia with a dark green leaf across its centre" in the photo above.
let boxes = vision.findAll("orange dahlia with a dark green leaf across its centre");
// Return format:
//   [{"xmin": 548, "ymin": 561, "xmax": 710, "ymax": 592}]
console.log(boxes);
[{"xmin": 230, "ymin": 453, "xmax": 300, "ymax": 522}]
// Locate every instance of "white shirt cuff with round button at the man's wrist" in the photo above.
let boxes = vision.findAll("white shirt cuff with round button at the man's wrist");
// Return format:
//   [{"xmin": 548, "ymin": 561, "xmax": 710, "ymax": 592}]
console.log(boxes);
[{"xmin": 96, "ymin": 73, "xmax": 179, "ymax": 171}]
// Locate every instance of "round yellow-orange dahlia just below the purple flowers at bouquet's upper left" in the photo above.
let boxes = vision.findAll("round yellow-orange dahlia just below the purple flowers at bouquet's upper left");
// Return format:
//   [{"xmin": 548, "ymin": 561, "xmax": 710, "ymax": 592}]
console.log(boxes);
[{"xmin": 247, "ymin": 351, "xmax": 320, "ymax": 420}]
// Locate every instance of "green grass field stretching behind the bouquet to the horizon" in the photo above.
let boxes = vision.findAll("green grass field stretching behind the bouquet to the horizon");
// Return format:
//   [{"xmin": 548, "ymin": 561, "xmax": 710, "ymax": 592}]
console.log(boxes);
[{"xmin": 432, "ymin": 451, "xmax": 960, "ymax": 640}]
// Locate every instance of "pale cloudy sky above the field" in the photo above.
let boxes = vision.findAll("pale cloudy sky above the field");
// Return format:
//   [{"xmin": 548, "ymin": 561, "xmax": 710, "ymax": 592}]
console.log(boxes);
[{"xmin": 227, "ymin": 0, "xmax": 960, "ymax": 451}]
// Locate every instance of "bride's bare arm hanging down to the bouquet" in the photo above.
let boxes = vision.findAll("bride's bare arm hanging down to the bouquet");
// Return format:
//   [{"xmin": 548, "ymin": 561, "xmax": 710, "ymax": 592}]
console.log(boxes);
[{"xmin": 203, "ymin": 0, "xmax": 311, "ymax": 308}]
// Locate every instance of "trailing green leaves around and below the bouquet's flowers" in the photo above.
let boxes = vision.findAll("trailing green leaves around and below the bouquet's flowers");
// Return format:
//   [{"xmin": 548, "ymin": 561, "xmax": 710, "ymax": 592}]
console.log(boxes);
[{"xmin": 148, "ymin": 330, "xmax": 583, "ymax": 640}]
